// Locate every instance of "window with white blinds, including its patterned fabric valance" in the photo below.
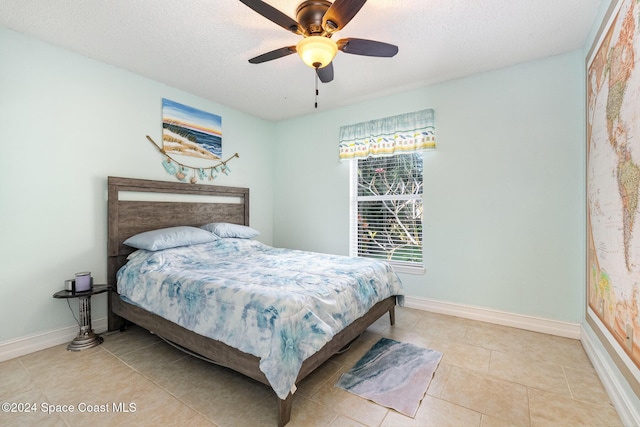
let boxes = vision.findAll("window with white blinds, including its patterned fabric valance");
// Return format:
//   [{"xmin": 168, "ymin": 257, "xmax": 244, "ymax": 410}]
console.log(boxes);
[{"xmin": 338, "ymin": 109, "xmax": 436, "ymax": 273}]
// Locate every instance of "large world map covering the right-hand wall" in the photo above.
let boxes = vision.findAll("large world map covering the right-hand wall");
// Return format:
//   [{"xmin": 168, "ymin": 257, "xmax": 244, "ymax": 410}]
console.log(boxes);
[{"xmin": 586, "ymin": 0, "xmax": 640, "ymax": 367}]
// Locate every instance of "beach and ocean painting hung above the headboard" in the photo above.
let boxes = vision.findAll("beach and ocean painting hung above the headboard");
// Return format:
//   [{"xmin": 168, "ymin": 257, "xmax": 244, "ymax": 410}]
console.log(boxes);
[{"xmin": 162, "ymin": 98, "xmax": 222, "ymax": 160}]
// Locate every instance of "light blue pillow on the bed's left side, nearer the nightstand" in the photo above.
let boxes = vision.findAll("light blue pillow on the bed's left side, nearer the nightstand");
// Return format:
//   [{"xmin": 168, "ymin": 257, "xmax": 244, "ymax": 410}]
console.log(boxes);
[{"xmin": 124, "ymin": 225, "xmax": 218, "ymax": 251}]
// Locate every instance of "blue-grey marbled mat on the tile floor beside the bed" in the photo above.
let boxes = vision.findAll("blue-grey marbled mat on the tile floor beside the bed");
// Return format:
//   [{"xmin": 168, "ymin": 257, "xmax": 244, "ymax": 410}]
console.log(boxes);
[{"xmin": 336, "ymin": 338, "xmax": 442, "ymax": 417}]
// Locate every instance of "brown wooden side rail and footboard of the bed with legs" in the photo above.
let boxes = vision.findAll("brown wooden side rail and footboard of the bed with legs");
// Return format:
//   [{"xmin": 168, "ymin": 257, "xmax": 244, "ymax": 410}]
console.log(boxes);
[{"xmin": 109, "ymin": 291, "xmax": 396, "ymax": 426}]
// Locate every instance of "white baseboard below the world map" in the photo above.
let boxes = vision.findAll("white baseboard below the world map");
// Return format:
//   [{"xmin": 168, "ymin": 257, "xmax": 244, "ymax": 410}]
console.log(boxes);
[{"xmin": 580, "ymin": 326, "xmax": 640, "ymax": 426}]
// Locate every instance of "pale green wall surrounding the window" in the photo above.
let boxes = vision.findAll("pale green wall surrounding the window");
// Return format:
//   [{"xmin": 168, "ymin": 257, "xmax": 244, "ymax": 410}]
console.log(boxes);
[{"xmin": 274, "ymin": 51, "xmax": 584, "ymax": 323}]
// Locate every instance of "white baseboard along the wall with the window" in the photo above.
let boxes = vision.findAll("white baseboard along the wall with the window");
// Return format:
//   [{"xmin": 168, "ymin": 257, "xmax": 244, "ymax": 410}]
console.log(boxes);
[{"xmin": 404, "ymin": 297, "xmax": 581, "ymax": 339}]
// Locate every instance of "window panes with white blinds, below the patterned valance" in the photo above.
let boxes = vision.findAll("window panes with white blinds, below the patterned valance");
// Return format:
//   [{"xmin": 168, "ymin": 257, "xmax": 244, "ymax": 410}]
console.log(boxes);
[{"xmin": 350, "ymin": 152, "xmax": 423, "ymax": 272}]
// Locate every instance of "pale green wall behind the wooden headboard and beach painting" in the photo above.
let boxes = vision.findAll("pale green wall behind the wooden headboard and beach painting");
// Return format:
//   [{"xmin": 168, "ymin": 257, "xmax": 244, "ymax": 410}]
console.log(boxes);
[{"xmin": 0, "ymin": 28, "xmax": 274, "ymax": 343}]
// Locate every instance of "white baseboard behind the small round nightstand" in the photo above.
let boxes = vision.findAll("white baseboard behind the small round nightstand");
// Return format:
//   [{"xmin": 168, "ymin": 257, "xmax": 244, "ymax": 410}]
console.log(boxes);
[{"xmin": 0, "ymin": 317, "xmax": 107, "ymax": 362}]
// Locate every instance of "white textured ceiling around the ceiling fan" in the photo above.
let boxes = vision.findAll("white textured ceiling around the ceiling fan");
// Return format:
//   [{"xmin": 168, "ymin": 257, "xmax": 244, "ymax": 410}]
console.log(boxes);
[{"xmin": 0, "ymin": 0, "xmax": 601, "ymax": 120}]
